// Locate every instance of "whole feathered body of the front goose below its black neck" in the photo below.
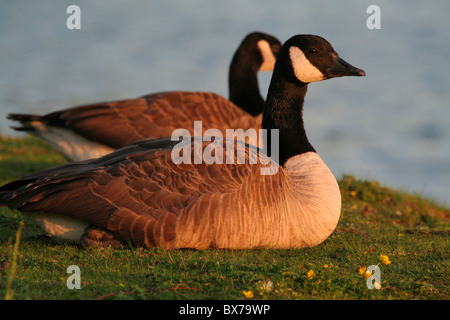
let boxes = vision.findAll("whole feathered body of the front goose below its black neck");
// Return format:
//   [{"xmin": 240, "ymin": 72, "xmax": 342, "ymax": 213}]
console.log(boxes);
[{"xmin": 0, "ymin": 136, "xmax": 339, "ymax": 249}]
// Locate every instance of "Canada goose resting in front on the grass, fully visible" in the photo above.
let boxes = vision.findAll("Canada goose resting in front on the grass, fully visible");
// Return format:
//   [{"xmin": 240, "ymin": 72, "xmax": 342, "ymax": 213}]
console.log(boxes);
[{"xmin": 0, "ymin": 35, "xmax": 365, "ymax": 249}]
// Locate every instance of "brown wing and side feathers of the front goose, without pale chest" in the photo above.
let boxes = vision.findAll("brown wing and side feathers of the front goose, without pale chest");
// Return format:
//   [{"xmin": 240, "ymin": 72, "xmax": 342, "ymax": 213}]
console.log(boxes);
[{"xmin": 0, "ymin": 139, "xmax": 282, "ymax": 248}]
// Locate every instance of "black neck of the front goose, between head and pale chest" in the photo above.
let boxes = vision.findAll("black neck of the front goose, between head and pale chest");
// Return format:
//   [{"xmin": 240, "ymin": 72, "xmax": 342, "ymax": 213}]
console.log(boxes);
[{"xmin": 262, "ymin": 74, "xmax": 315, "ymax": 165}]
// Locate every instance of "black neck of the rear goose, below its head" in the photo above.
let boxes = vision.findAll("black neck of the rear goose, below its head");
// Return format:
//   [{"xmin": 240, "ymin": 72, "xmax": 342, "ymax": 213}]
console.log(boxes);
[{"xmin": 228, "ymin": 64, "xmax": 264, "ymax": 116}]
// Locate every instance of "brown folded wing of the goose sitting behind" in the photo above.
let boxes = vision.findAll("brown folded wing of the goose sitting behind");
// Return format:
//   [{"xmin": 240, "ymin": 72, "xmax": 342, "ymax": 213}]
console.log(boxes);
[{"xmin": 60, "ymin": 92, "xmax": 261, "ymax": 148}]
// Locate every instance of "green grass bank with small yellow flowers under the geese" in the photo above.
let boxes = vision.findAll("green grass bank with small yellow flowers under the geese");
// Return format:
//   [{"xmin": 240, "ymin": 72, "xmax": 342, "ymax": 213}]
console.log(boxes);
[{"xmin": 0, "ymin": 138, "xmax": 450, "ymax": 300}]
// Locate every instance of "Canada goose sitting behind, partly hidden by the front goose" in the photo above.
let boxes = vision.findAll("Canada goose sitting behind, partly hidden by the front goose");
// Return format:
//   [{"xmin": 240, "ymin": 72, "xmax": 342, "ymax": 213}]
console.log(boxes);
[{"xmin": 8, "ymin": 32, "xmax": 281, "ymax": 161}]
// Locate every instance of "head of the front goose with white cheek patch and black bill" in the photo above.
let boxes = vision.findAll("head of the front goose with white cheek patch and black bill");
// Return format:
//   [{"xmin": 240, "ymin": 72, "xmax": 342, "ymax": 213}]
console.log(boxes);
[{"xmin": 277, "ymin": 35, "xmax": 366, "ymax": 83}]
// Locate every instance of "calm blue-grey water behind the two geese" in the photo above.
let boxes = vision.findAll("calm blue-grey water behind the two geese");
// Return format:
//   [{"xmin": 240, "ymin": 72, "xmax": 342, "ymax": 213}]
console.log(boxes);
[{"xmin": 0, "ymin": 0, "xmax": 450, "ymax": 204}]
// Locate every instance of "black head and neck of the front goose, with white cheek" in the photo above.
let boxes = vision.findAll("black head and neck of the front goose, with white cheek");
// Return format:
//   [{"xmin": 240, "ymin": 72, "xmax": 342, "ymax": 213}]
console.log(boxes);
[{"xmin": 262, "ymin": 35, "xmax": 365, "ymax": 164}]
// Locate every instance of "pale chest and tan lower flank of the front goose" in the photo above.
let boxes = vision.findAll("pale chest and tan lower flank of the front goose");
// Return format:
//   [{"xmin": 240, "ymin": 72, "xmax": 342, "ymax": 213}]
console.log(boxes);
[{"xmin": 172, "ymin": 152, "xmax": 341, "ymax": 248}]
